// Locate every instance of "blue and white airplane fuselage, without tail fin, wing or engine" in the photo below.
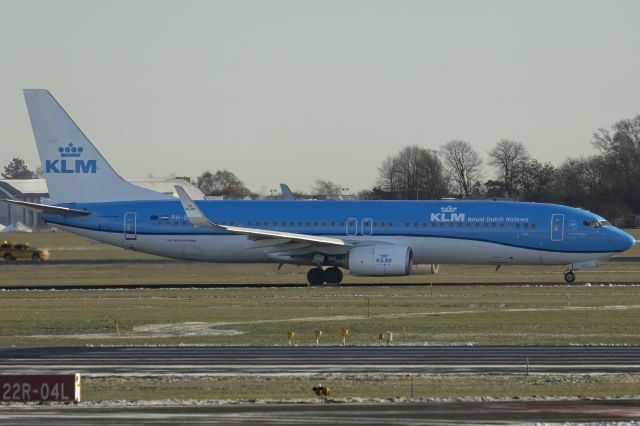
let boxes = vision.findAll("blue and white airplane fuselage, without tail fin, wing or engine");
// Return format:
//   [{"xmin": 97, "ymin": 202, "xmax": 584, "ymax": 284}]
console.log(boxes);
[{"xmin": 45, "ymin": 200, "xmax": 632, "ymax": 264}]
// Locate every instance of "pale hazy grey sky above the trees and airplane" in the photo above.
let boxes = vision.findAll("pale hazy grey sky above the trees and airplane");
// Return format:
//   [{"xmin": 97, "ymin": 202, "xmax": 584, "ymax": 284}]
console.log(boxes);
[{"xmin": 0, "ymin": 0, "xmax": 640, "ymax": 193}]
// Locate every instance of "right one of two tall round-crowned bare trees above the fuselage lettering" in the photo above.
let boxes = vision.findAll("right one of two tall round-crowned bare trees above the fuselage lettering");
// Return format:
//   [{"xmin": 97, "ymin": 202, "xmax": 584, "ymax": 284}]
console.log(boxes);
[{"xmin": 488, "ymin": 139, "xmax": 529, "ymax": 198}]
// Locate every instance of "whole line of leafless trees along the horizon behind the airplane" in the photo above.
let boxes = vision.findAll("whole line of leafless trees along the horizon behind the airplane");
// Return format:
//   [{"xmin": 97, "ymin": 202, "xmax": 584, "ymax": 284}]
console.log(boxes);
[{"xmin": 2, "ymin": 114, "xmax": 640, "ymax": 218}]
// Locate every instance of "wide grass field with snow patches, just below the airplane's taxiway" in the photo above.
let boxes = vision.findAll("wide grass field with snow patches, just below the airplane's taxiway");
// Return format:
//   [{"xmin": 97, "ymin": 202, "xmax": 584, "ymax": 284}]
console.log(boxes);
[{"xmin": 0, "ymin": 278, "xmax": 640, "ymax": 345}]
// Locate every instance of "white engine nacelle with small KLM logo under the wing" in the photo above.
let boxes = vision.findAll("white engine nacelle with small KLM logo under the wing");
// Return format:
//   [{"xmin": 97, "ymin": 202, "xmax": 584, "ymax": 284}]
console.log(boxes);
[{"xmin": 349, "ymin": 244, "xmax": 413, "ymax": 277}]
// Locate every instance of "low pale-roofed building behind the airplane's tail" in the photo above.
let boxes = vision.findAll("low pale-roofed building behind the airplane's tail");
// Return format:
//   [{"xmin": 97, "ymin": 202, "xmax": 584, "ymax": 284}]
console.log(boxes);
[{"xmin": 0, "ymin": 179, "xmax": 204, "ymax": 229}]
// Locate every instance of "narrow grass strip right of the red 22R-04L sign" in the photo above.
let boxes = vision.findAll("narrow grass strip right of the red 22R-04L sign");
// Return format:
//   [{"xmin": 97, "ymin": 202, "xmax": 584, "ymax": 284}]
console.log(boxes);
[{"xmin": 82, "ymin": 374, "xmax": 640, "ymax": 401}]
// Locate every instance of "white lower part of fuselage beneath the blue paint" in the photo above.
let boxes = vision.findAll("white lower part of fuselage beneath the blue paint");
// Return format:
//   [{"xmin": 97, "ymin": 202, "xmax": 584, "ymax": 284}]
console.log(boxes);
[{"xmin": 59, "ymin": 225, "xmax": 615, "ymax": 265}]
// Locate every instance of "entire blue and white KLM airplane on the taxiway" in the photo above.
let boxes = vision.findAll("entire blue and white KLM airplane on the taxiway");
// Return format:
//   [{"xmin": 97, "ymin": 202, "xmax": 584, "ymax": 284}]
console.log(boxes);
[{"xmin": 7, "ymin": 89, "xmax": 635, "ymax": 285}]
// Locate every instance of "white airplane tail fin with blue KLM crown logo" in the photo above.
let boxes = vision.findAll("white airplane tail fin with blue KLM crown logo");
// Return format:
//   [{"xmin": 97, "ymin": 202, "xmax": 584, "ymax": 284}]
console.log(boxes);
[{"xmin": 24, "ymin": 89, "xmax": 169, "ymax": 203}]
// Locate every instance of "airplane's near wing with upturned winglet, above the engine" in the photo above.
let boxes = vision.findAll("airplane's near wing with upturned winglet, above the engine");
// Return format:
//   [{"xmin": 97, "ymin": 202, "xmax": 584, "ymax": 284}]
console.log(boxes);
[{"xmin": 175, "ymin": 185, "xmax": 353, "ymax": 247}]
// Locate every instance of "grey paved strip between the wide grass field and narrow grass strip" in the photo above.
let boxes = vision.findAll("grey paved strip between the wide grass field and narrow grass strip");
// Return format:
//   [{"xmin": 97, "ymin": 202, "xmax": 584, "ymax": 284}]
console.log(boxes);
[{"xmin": 0, "ymin": 346, "xmax": 640, "ymax": 376}]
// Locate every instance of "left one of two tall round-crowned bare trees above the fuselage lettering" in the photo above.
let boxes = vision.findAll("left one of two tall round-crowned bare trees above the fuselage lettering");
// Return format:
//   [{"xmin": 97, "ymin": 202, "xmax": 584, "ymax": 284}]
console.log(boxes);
[{"xmin": 440, "ymin": 140, "xmax": 482, "ymax": 198}]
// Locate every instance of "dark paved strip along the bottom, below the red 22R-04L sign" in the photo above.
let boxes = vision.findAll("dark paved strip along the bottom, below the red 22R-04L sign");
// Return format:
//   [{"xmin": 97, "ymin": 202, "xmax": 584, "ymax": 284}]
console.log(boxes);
[{"xmin": 0, "ymin": 400, "xmax": 640, "ymax": 426}]
